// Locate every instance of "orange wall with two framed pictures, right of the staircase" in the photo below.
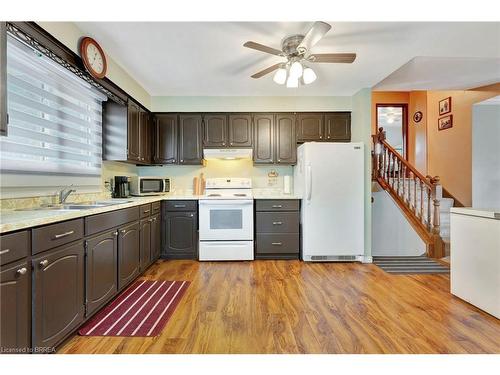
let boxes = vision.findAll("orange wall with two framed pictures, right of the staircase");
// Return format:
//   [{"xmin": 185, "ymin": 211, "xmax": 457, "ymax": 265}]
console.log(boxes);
[{"xmin": 427, "ymin": 84, "xmax": 500, "ymax": 206}]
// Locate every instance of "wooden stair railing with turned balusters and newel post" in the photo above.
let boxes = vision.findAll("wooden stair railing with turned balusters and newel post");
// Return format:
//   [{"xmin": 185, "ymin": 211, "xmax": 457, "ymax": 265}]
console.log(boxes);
[{"xmin": 372, "ymin": 128, "xmax": 444, "ymax": 258}]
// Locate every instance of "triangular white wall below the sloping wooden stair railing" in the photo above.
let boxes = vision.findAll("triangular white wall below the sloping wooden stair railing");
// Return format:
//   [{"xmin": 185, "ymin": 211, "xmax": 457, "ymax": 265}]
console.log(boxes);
[{"xmin": 372, "ymin": 183, "xmax": 426, "ymax": 256}]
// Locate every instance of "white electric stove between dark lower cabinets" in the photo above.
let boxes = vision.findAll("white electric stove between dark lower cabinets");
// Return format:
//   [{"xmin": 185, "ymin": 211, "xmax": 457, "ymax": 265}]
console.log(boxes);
[{"xmin": 198, "ymin": 178, "xmax": 254, "ymax": 261}]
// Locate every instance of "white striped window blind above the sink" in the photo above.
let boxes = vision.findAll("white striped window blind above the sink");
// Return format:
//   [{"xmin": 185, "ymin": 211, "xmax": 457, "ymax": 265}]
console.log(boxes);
[{"xmin": 0, "ymin": 36, "xmax": 106, "ymax": 176}]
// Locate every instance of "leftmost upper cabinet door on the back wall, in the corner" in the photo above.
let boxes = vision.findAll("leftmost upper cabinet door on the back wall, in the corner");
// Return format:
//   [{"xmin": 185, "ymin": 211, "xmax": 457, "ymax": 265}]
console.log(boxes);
[{"xmin": 153, "ymin": 114, "xmax": 178, "ymax": 164}]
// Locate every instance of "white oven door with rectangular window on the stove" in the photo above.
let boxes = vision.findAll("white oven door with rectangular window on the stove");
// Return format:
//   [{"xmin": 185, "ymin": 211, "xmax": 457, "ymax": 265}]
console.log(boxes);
[{"xmin": 199, "ymin": 199, "xmax": 253, "ymax": 241}]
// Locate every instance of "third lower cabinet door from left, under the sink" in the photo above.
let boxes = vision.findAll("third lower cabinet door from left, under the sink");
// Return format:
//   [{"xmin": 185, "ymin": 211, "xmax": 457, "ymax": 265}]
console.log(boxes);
[{"xmin": 85, "ymin": 230, "xmax": 118, "ymax": 316}]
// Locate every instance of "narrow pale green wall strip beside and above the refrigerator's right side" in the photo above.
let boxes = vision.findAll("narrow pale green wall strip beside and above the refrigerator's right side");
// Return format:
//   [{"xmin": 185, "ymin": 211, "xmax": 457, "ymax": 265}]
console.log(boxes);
[{"xmin": 351, "ymin": 89, "xmax": 372, "ymax": 261}]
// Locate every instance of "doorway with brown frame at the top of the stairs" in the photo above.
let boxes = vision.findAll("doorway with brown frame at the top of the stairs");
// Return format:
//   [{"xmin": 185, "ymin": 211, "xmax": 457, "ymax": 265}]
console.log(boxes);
[{"xmin": 377, "ymin": 104, "xmax": 408, "ymax": 160}]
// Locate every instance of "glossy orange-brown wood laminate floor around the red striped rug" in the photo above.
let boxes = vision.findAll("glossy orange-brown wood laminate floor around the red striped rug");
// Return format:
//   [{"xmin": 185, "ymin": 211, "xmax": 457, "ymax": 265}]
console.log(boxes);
[{"xmin": 59, "ymin": 261, "xmax": 500, "ymax": 353}]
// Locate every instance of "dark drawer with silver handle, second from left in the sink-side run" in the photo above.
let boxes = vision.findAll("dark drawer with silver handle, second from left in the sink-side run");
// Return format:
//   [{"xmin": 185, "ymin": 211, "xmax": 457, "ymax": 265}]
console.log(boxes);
[{"xmin": 32, "ymin": 219, "xmax": 83, "ymax": 254}]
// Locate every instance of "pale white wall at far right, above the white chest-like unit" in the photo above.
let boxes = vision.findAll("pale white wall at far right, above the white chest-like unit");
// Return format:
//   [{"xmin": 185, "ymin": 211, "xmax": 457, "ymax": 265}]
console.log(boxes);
[{"xmin": 472, "ymin": 96, "xmax": 500, "ymax": 208}]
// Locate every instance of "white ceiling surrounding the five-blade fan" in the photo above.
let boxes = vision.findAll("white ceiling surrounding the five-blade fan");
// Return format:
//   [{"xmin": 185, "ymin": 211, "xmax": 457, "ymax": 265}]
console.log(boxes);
[{"xmin": 77, "ymin": 21, "xmax": 500, "ymax": 96}]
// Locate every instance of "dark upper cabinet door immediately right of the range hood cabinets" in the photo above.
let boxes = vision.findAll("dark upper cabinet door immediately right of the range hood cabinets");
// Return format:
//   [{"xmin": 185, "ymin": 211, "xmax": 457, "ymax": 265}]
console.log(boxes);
[{"xmin": 253, "ymin": 114, "xmax": 274, "ymax": 164}]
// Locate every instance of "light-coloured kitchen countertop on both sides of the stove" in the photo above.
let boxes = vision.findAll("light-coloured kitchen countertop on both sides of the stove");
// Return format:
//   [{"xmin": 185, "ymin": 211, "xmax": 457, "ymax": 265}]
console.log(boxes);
[{"xmin": 0, "ymin": 192, "xmax": 300, "ymax": 233}]
